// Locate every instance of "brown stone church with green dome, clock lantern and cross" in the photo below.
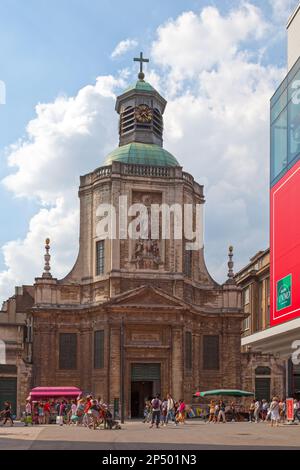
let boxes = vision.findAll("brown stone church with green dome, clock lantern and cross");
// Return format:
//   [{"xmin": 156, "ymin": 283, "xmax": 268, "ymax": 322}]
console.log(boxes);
[{"xmin": 0, "ymin": 58, "xmax": 245, "ymax": 417}]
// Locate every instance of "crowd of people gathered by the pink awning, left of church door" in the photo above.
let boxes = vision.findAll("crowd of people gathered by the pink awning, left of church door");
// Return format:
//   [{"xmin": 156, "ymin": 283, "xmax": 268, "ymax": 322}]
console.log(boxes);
[{"xmin": 19, "ymin": 395, "xmax": 120, "ymax": 429}]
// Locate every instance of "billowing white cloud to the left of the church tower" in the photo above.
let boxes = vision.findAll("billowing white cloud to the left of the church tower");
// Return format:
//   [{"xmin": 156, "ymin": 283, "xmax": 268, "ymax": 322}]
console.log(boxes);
[{"xmin": 0, "ymin": 76, "xmax": 125, "ymax": 298}]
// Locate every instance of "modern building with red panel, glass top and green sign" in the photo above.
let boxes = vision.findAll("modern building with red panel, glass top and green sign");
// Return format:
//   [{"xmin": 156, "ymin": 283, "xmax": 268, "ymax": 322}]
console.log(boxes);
[{"xmin": 242, "ymin": 5, "xmax": 300, "ymax": 397}]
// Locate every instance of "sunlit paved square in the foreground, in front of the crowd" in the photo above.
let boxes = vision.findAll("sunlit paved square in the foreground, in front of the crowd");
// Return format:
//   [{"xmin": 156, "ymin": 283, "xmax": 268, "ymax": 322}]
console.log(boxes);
[{"xmin": 0, "ymin": 420, "xmax": 300, "ymax": 450}]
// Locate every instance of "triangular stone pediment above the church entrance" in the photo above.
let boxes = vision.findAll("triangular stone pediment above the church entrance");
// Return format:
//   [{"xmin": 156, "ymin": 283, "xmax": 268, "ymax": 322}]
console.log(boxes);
[{"xmin": 109, "ymin": 286, "xmax": 191, "ymax": 309}]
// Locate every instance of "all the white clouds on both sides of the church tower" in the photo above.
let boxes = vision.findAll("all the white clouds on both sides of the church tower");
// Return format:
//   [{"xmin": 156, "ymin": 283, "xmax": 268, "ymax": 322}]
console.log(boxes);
[{"xmin": 0, "ymin": 3, "xmax": 284, "ymax": 297}]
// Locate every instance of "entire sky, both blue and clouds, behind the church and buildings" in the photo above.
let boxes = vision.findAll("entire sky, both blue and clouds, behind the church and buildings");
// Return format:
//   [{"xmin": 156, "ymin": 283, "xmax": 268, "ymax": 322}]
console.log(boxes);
[{"xmin": 0, "ymin": 0, "xmax": 298, "ymax": 301}]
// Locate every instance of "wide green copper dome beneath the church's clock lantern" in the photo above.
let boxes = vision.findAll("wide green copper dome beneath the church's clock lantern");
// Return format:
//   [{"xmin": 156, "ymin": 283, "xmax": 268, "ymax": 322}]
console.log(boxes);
[{"xmin": 105, "ymin": 142, "xmax": 180, "ymax": 166}]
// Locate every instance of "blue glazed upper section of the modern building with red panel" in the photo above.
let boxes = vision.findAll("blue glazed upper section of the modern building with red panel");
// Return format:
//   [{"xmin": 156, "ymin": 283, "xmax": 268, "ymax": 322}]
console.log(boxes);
[{"xmin": 271, "ymin": 57, "xmax": 300, "ymax": 187}]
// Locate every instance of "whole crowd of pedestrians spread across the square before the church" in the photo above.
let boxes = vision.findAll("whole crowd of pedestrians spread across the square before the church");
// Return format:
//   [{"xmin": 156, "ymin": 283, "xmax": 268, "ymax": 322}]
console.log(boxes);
[{"xmin": 0, "ymin": 394, "xmax": 300, "ymax": 429}]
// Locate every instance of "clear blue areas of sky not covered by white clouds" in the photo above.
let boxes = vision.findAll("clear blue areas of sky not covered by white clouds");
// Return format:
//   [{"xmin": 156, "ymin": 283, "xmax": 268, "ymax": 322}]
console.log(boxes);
[{"xmin": 0, "ymin": 0, "xmax": 297, "ymax": 300}]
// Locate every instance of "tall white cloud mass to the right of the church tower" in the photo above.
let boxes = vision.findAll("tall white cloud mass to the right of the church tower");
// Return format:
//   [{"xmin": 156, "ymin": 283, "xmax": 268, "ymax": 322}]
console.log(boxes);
[{"xmin": 152, "ymin": 4, "xmax": 284, "ymax": 280}]
